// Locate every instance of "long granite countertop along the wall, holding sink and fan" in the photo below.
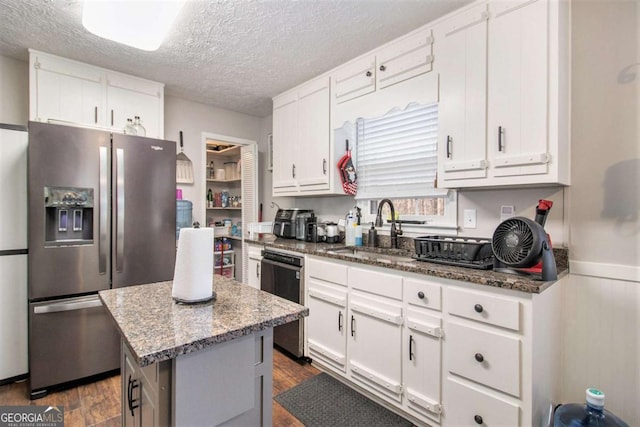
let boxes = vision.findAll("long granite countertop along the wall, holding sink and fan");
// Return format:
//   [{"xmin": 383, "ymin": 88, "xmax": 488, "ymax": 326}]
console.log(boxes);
[{"xmin": 245, "ymin": 237, "xmax": 568, "ymax": 293}]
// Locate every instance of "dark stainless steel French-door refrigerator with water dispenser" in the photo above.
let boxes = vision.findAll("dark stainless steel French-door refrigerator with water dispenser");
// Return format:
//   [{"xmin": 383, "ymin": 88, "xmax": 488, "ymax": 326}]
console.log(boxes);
[{"xmin": 28, "ymin": 122, "xmax": 176, "ymax": 398}]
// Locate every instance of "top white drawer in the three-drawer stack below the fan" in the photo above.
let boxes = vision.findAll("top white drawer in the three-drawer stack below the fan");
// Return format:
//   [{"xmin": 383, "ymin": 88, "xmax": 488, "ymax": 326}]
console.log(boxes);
[{"xmin": 446, "ymin": 288, "xmax": 520, "ymax": 331}]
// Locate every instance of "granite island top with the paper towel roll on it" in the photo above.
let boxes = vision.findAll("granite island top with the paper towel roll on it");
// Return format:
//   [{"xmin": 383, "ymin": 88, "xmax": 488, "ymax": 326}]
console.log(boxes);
[{"xmin": 99, "ymin": 276, "xmax": 309, "ymax": 366}]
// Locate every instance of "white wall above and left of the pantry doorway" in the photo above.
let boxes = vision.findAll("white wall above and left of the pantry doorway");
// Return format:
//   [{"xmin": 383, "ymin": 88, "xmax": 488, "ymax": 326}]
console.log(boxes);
[{"xmin": 164, "ymin": 96, "xmax": 266, "ymax": 224}]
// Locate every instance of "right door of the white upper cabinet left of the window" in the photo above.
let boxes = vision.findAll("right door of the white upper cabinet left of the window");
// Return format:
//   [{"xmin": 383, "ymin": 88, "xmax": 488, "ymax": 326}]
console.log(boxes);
[{"xmin": 295, "ymin": 77, "xmax": 330, "ymax": 191}]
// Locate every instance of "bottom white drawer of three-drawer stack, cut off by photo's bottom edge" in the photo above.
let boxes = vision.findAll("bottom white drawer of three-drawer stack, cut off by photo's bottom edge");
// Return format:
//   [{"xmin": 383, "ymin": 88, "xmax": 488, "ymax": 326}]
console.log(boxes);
[{"xmin": 444, "ymin": 380, "xmax": 520, "ymax": 427}]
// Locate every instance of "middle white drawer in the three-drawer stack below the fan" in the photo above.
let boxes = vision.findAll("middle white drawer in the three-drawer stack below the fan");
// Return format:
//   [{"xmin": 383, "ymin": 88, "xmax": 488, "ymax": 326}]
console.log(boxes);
[{"xmin": 445, "ymin": 323, "xmax": 520, "ymax": 397}]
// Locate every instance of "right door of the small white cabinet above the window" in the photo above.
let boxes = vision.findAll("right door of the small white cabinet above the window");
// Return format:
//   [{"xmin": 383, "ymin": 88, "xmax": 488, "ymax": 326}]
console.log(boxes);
[{"xmin": 376, "ymin": 30, "xmax": 433, "ymax": 89}]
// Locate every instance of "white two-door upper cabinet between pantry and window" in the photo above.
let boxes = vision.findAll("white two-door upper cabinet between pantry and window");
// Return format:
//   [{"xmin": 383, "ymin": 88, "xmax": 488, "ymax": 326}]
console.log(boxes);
[{"xmin": 273, "ymin": 77, "xmax": 333, "ymax": 195}]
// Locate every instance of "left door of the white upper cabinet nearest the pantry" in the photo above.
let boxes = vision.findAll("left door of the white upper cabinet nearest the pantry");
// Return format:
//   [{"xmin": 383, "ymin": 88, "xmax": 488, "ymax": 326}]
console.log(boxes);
[{"xmin": 273, "ymin": 93, "xmax": 298, "ymax": 194}]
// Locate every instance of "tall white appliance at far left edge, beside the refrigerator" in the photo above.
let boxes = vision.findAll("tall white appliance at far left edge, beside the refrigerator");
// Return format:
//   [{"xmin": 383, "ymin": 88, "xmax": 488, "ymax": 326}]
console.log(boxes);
[{"xmin": 0, "ymin": 124, "xmax": 28, "ymax": 384}]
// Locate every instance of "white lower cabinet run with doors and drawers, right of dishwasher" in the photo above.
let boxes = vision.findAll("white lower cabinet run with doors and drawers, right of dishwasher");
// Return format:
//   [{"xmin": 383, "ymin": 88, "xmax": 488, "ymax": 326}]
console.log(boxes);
[{"xmin": 305, "ymin": 256, "xmax": 561, "ymax": 427}]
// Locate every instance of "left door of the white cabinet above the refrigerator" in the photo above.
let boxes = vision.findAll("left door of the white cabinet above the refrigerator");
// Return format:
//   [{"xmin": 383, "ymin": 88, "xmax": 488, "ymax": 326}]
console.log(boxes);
[{"xmin": 30, "ymin": 55, "xmax": 104, "ymax": 125}]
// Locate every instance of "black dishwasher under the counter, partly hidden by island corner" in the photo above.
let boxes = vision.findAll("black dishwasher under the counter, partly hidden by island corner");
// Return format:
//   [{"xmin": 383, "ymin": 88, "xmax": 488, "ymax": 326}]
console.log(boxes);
[{"xmin": 260, "ymin": 249, "xmax": 304, "ymax": 357}]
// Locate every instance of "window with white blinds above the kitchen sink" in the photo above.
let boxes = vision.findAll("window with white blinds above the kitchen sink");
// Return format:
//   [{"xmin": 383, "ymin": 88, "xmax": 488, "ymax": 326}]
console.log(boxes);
[{"xmin": 356, "ymin": 104, "xmax": 457, "ymax": 233}]
